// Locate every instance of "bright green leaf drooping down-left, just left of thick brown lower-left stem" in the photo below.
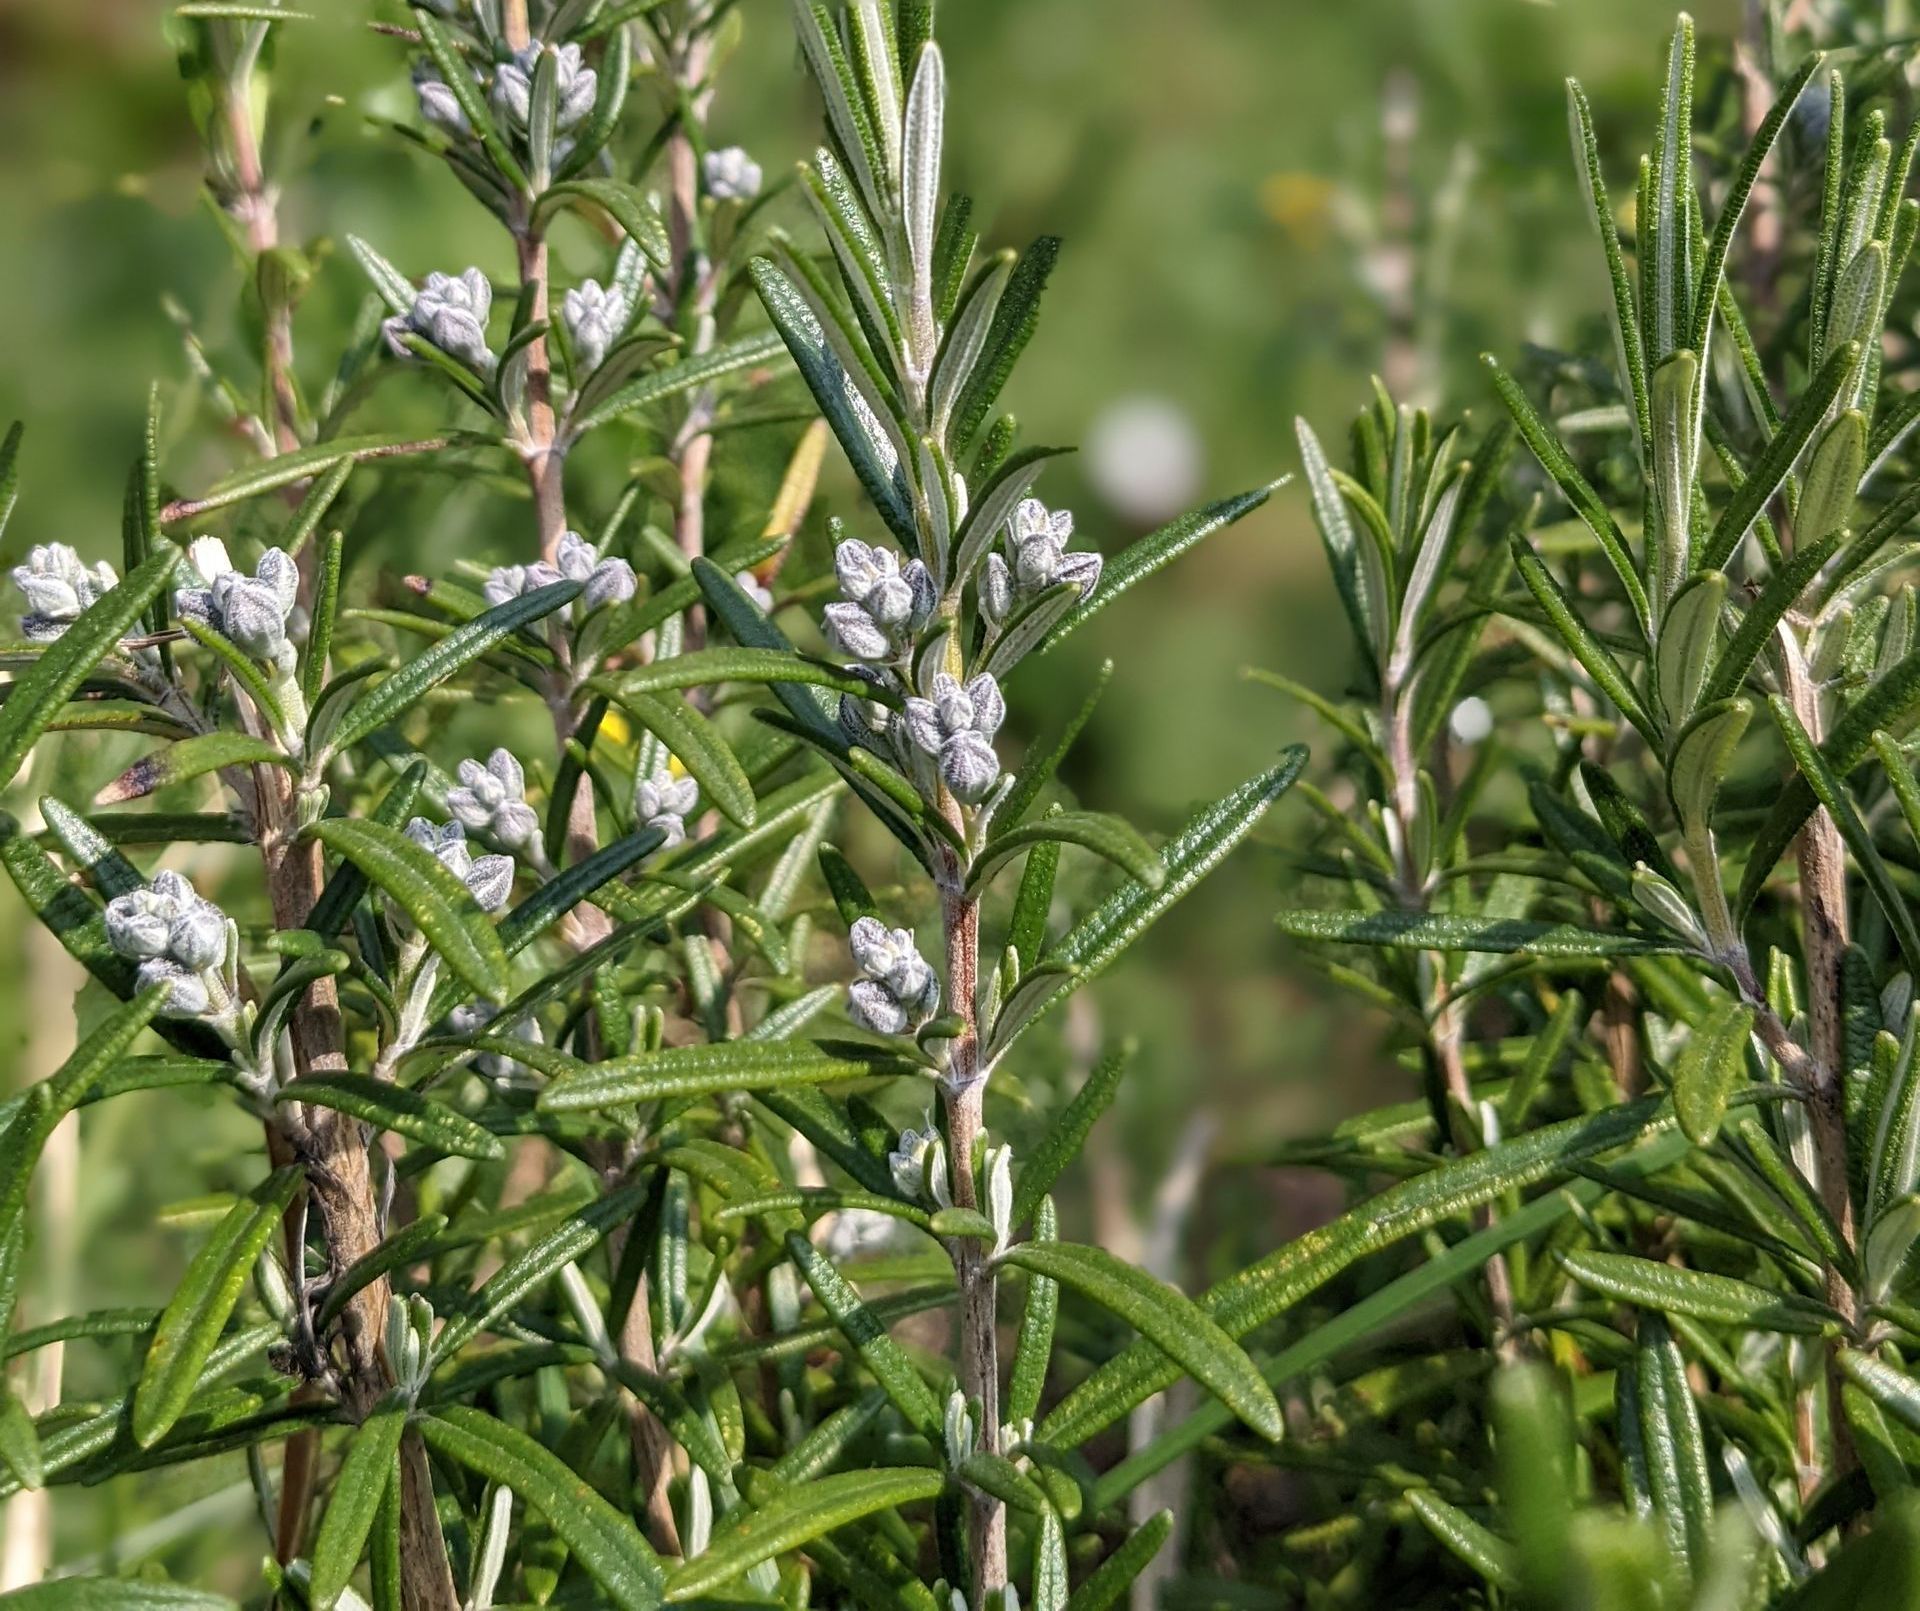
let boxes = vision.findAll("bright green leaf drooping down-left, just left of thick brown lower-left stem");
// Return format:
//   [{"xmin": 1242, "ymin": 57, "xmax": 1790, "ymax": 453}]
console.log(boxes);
[{"xmin": 132, "ymin": 1167, "xmax": 303, "ymax": 1448}]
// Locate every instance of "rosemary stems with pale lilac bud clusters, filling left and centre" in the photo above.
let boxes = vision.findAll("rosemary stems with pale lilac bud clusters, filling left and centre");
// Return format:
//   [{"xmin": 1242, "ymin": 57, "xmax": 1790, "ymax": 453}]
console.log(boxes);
[{"xmin": 0, "ymin": 0, "xmax": 1304, "ymax": 1611}]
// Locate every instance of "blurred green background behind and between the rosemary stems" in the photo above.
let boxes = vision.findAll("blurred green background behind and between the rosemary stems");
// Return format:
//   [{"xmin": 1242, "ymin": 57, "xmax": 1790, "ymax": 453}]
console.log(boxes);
[{"xmin": 0, "ymin": 0, "xmax": 1738, "ymax": 1589}]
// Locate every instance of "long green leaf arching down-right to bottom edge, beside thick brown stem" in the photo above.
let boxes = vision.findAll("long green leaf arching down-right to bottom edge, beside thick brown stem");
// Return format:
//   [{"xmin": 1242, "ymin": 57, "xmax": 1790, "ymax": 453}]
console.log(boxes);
[{"xmin": 419, "ymin": 1404, "xmax": 666, "ymax": 1611}]
